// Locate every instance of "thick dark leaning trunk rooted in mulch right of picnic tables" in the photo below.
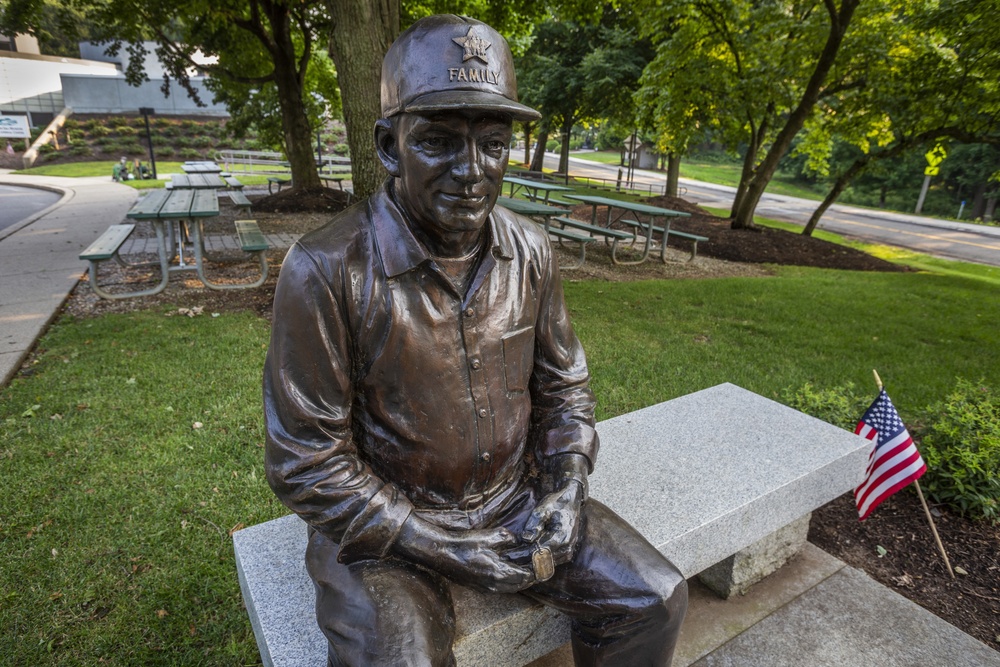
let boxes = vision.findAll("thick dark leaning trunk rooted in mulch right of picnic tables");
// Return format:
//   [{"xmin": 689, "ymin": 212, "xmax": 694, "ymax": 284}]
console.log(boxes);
[{"xmin": 732, "ymin": 0, "xmax": 860, "ymax": 229}]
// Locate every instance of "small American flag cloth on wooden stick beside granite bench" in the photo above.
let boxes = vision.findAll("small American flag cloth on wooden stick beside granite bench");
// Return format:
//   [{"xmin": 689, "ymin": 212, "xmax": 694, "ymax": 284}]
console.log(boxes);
[{"xmin": 854, "ymin": 389, "xmax": 927, "ymax": 521}]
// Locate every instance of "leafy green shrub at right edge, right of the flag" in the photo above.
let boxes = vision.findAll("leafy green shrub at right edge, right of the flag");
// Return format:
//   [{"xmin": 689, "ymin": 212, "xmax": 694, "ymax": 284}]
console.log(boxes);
[{"xmin": 920, "ymin": 380, "xmax": 1000, "ymax": 523}]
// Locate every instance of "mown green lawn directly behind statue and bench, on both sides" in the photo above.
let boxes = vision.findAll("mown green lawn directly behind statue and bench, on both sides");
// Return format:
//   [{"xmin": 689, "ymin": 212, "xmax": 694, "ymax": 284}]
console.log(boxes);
[{"xmin": 0, "ymin": 250, "xmax": 1000, "ymax": 666}]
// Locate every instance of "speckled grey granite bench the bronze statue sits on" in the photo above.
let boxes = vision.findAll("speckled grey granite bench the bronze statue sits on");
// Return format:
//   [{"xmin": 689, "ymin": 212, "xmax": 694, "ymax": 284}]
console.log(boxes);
[{"xmin": 233, "ymin": 384, "xmax": 870, "ymax": 667}]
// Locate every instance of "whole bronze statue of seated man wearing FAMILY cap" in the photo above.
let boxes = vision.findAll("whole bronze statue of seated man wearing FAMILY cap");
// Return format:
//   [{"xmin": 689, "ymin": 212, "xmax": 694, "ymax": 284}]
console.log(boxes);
[{"xmin": 264, "ymin": 16, "xmax": 687, "ymax": 667}]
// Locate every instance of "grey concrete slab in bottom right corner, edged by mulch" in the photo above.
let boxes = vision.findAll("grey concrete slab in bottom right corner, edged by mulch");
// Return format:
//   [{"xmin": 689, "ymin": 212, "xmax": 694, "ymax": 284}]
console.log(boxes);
[{"xmin": 694, "ymin": 567, "xmax": 1000, "ymax": 667}]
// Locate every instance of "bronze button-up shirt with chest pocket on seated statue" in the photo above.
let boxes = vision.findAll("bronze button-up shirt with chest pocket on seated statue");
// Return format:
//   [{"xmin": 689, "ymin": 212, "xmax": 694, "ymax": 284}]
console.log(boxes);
[{"xmin": 264, "ymin": 182, "xmax": 598, "ymax": 562}]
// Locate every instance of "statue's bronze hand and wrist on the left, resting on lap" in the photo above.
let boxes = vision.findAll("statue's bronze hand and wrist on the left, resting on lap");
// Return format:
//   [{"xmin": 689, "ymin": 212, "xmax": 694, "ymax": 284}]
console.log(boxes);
[{"xmin": 395, "ymin": 514, "xmax": 535, "ymax": 593}]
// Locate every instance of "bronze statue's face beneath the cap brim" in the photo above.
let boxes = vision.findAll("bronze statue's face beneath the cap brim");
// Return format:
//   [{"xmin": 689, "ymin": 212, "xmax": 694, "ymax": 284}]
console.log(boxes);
[{"xmin": 386, "ymin": 111, "xmax": 512, "ymax": 248}]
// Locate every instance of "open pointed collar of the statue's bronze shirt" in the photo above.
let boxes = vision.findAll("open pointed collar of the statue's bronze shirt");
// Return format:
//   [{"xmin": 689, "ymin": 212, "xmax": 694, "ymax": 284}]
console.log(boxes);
[{"xmin": 376, "ymin": 178, "xmax": 514, "ymax": 278}]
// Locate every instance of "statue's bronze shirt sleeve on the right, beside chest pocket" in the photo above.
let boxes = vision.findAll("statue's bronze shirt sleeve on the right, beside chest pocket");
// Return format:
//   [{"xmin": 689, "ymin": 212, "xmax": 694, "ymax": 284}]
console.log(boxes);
[{"xmin": 531, "ymin": 224, "xmax": 600, "ymax": 472}]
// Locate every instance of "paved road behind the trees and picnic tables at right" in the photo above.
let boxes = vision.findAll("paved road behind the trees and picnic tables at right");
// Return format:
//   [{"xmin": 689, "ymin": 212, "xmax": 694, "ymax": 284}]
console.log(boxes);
[{"xmin": 545, "ymin": 154, "xmax": 1000, "ymax": 266}]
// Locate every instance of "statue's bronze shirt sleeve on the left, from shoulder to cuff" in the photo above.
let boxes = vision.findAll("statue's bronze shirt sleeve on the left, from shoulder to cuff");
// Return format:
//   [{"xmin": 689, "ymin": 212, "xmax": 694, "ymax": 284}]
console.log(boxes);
[{"xmin": 264, "ymin": 245, "xmax": 413, "ymax": 563}]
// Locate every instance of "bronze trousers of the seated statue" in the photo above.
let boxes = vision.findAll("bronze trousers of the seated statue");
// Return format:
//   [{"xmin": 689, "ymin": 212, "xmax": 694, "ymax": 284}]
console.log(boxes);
[{"xmin": 306, "ymin": 486, "xmax": 687, "ymax": 667}]
